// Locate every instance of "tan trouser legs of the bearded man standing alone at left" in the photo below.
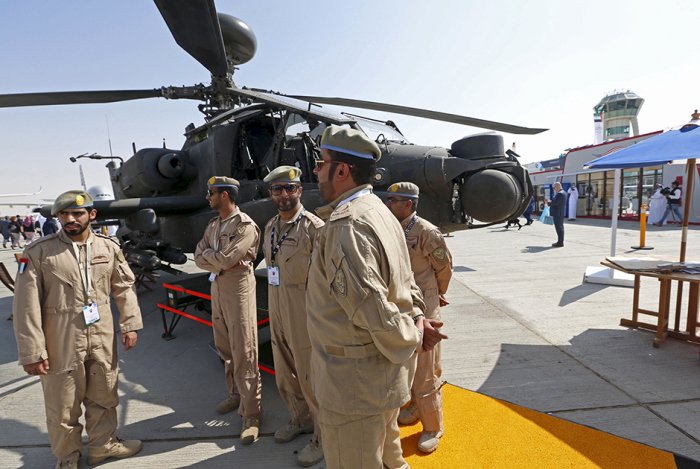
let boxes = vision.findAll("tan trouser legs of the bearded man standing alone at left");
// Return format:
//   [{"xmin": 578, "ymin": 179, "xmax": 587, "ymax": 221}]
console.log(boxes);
[{"xmin": 41, "ymin": 360, "xmax": 119, "ymax": 459}]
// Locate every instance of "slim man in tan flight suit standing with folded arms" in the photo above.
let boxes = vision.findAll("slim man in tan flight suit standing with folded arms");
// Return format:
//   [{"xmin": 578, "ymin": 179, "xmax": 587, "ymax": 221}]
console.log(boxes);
[{"xmin": 194, "ymin": 176, "xmax": 261, "ymax": 445}]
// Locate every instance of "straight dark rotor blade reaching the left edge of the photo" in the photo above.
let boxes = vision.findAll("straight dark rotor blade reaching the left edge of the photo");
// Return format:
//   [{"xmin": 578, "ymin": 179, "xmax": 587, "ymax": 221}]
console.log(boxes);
[{"xmin": 0, "ymin": 89, "xmax": 163, "ymax": 108}]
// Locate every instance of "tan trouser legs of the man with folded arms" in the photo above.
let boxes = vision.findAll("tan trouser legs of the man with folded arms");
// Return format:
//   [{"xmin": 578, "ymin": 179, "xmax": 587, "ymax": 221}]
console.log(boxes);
[{"xmin": 211, "ymin": 267, "xmax": 262, "ymax": 418}]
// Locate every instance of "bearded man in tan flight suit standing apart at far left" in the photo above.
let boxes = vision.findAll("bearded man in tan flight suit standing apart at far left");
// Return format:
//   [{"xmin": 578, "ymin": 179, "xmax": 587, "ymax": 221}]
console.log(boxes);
[{"xmin": 12, "ymin": 191, "xmax": 143, "ymax": 468}]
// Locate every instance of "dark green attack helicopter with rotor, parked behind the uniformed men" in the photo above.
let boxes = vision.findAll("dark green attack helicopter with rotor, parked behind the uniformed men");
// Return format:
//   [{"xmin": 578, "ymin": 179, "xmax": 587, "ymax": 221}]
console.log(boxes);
[{"xmin": 0, "ymin": 0, "xmax": 546, "ymax": 269}]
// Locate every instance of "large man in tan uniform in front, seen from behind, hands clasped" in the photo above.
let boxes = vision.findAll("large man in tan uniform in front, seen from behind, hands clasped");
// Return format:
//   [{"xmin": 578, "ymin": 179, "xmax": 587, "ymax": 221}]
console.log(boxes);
[{"xmin": 306, "ymin": 126, "xmax": 446, "ymax": 469}]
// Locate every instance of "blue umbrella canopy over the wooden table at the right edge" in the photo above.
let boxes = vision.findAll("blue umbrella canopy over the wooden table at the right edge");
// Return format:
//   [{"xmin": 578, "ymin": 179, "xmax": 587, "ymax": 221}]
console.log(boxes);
[{"xmin": 585, "ymin": 124, "xmax": 700, "ymax": 169}]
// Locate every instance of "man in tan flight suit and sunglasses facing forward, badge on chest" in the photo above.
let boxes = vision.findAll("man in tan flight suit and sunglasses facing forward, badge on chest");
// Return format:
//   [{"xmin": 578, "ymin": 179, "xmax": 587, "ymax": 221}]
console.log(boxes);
[{"xmin": 263, "ymin": 166, "xmax": 323, "ymax": 467}]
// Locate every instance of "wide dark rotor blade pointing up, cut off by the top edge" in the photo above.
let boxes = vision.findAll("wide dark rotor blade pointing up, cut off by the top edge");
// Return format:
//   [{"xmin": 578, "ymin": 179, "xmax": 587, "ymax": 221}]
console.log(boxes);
[{"xmin": 154, "ymin": 0, "xmax": 228, "ymax": 76}]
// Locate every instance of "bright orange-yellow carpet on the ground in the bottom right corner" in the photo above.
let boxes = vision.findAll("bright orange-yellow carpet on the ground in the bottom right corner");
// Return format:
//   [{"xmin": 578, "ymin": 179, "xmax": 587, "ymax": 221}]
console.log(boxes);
[{"xmin": 401, "ymin": 384, "xmax": 676, "ymax": 469}]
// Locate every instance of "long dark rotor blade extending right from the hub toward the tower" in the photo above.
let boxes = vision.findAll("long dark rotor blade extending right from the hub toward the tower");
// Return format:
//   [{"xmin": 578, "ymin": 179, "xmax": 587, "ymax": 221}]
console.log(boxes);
[{"xmin": 289, "ymin": 95, "xmax": 547, "ymax": 135}]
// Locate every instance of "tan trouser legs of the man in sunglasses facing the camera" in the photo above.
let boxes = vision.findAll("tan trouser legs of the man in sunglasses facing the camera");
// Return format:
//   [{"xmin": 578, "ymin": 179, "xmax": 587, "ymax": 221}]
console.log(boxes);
[{"xmin": 269, "ymin": 300, "xmax": 320, "ymax": 441}]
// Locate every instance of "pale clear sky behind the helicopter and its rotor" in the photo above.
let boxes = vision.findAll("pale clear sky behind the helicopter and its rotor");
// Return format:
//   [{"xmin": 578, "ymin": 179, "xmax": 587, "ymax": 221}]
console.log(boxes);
[{"xmin": 0, "ymin": 0, "xmax": 700, "ymax": 205}]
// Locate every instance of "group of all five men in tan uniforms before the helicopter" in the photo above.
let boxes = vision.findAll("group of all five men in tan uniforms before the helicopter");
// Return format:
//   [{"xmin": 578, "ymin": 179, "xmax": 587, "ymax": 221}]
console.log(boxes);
[{"xmin": 13, "ymin": 126, "xmax": 452, "ymax": 468}]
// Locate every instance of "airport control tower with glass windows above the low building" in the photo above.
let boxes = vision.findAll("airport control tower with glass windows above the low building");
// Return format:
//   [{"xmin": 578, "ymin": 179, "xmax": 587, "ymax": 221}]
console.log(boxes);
[{"xmin": 593, "ymin": 90, "xmax": 644, "ymax": 143}]
